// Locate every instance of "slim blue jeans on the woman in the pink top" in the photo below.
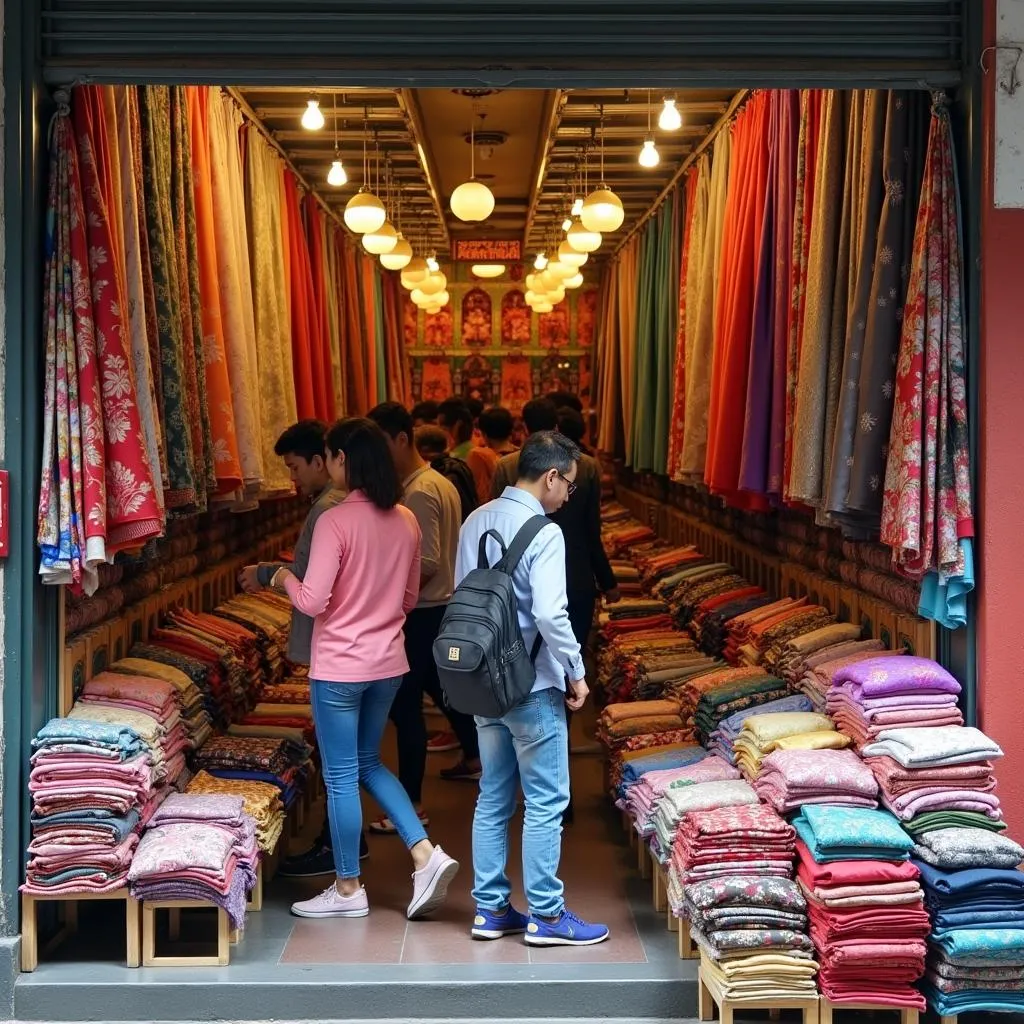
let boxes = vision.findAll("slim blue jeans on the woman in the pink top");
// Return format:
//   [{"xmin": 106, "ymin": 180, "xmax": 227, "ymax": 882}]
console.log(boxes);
[{"xmin": 309, "ymin": 677, "xmax": 427, "ymax": 879}]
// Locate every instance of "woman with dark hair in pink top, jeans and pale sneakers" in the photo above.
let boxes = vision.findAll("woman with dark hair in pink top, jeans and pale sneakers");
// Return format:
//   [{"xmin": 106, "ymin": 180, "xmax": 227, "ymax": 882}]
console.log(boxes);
[{"xmin": 273, "ymin": 419, "xmax": 459, "ymax": 920}]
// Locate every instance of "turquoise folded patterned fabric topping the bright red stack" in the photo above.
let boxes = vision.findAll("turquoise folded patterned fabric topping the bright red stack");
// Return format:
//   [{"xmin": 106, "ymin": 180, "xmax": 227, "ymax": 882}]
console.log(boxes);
[{"xmin": 793, "ymin": 804, "xmax": 913, "ymax": 860}]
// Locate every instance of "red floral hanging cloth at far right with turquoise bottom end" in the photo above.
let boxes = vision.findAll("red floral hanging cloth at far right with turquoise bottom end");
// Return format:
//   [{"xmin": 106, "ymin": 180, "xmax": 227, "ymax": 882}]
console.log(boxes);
[{"xmin": 882, "ymin": 97, "xmax": 974, "ymax": 627}]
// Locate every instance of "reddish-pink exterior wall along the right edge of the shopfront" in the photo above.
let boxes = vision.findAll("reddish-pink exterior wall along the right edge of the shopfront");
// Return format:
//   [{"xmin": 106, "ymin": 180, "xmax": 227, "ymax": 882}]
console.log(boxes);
[{"xmin": 978, "ymin": 0, "xmax": 1024, "ymax": 839}]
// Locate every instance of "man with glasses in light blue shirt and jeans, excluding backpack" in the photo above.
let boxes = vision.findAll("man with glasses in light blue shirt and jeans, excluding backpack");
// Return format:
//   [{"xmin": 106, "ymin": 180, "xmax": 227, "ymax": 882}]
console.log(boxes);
[{"xmin": 456, "ymin": 431, "xmax": 608, "ymax": 946}]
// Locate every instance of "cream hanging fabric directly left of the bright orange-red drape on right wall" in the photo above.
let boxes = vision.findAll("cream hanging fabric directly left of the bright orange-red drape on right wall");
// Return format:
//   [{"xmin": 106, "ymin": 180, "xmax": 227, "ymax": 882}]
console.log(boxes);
[{"xmin": 680, "ymin": 131, "xmax": 732, "ymax": 483}]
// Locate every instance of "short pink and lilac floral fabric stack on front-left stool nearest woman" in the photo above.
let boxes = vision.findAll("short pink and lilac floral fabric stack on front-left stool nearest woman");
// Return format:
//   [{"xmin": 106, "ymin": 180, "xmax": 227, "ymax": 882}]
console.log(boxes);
[{"xmin": 128, "ymin": 794, "xmax": 259, "ymax": 928}]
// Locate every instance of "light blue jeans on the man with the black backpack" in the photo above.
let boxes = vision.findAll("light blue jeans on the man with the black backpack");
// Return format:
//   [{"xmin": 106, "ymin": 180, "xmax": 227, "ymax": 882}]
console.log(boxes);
[{"xmin": 473, "ymin": 688, "xmax": 569, "ymax": 918}]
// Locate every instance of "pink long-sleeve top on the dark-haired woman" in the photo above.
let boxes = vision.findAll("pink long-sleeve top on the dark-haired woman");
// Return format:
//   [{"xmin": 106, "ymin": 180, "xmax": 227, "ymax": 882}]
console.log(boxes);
[{"xmin": 285, "ymin": 490, "xmax": 420, "ymax": 683}]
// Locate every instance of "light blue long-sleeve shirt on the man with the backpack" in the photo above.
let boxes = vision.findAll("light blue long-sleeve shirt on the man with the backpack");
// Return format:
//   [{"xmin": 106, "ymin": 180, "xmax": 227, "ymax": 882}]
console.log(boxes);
[{"xmin": 455, "ymin": 487, "xmax": 584, "ymax": 693}]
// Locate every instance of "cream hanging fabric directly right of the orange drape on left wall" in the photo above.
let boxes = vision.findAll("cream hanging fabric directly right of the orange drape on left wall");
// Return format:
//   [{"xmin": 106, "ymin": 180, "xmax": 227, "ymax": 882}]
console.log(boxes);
[{"xmin": 200, "ymin": 89, "xmax": 262, "ymax": 496}]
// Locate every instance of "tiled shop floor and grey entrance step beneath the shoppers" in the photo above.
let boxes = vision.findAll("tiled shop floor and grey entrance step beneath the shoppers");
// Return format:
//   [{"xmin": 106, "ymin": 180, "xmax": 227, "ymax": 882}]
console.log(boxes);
[{"xmin": 15, "ymin": 720, "xmax": 695, "ymax": 1021}]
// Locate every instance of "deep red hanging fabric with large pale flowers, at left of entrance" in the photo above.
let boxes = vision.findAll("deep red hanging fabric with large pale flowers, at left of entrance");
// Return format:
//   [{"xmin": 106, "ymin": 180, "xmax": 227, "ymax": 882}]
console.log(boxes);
[{"xmin": 73, "ymin": 93, "xmax": 163, "ymax": 557}]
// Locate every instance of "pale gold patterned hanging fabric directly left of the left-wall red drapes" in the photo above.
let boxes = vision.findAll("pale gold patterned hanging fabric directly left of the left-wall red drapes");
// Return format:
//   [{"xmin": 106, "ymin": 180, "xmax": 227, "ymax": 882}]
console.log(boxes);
[{"xmin": 246, "ymin": 123, "xmax": 298, "ymax": 493}]
